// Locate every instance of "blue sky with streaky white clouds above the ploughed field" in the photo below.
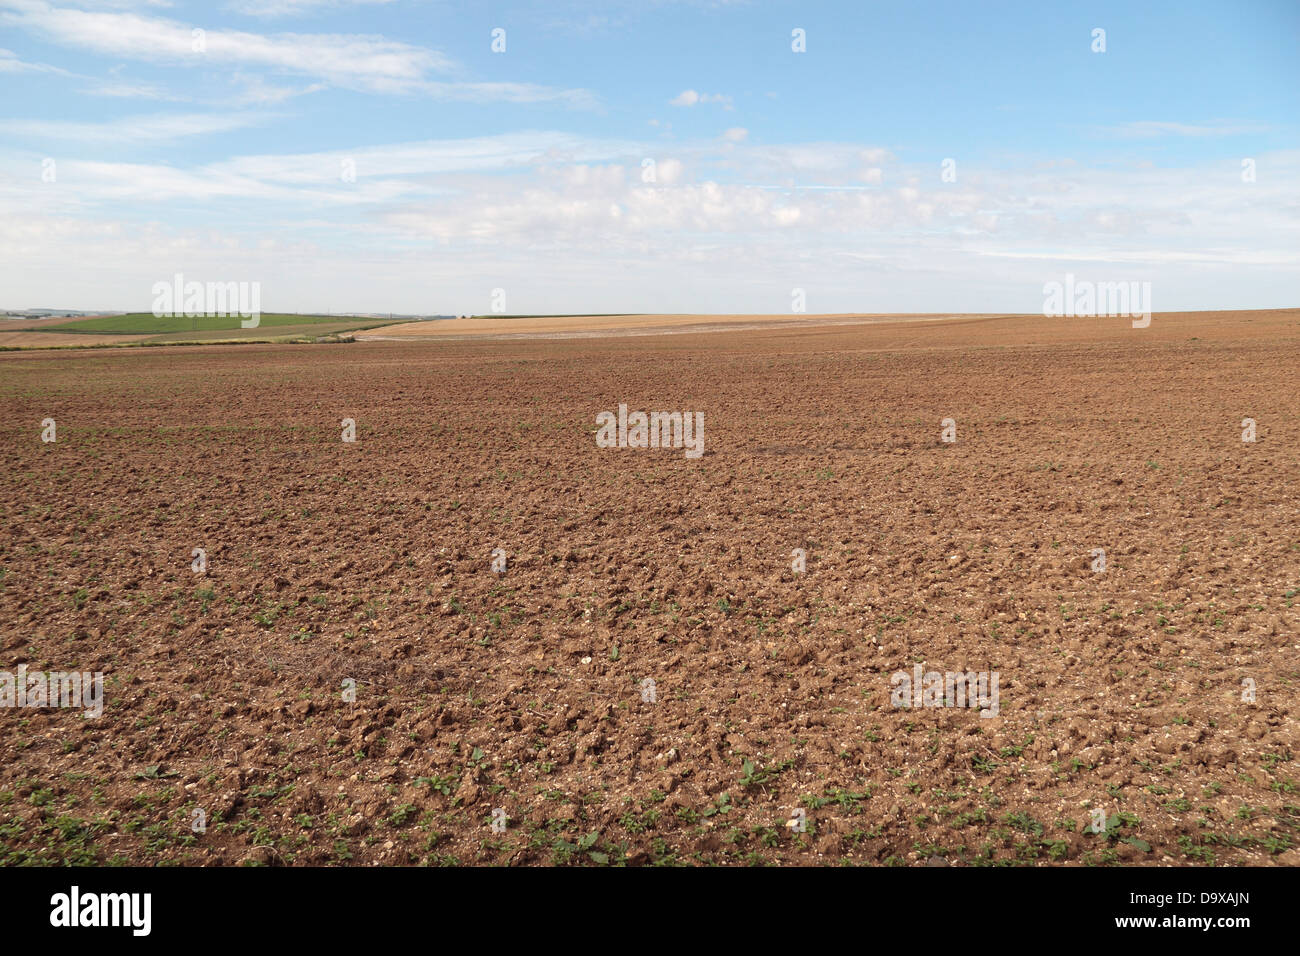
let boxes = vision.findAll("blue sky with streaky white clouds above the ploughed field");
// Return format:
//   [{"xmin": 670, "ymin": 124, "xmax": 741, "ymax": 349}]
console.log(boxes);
[{"xmin": 0, "ymin": 0, "xmax": 1300, "ymax": 312}]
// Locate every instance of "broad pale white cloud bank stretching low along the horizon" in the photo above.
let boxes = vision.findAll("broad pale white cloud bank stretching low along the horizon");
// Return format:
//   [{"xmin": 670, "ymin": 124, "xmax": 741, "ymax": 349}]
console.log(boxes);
[{"xmin": 0, "ymin": 129, "xmax": 1300, "ymax": 312}]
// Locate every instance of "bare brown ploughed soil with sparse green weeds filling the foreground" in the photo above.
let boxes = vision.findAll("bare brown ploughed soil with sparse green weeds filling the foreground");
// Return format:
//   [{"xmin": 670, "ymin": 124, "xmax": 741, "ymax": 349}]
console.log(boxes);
[{"xmin": 0, "ymin": 310, "xmax": 1300, "ymax": 865}]
